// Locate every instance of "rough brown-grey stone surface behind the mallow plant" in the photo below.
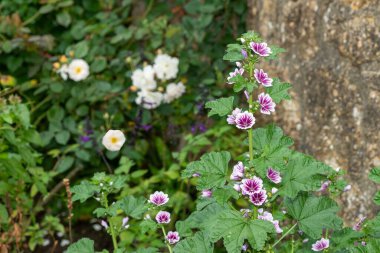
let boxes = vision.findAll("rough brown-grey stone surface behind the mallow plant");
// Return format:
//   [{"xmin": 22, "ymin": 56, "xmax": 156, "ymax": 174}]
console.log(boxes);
[{"xmin": 248, "ymin": 0, "xmax": 380, "ymax": 222}]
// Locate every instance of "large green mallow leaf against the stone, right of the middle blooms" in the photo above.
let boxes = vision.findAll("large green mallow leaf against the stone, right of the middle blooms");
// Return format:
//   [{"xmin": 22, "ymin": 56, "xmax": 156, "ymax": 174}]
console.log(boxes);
[{"xmin": 278, "ymin": 153, "xmax": 331, "ymax": 198}]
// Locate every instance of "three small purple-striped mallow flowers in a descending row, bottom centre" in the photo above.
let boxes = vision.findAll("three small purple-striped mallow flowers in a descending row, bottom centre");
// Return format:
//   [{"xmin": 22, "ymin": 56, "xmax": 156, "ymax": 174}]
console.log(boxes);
[{"xmin": 149, "ymin": 191, "xmax": 180, "ymax": 244}]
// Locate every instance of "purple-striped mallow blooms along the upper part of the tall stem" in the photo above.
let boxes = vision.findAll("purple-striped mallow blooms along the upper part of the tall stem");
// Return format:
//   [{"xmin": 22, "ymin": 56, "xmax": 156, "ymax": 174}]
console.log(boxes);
[{"xmin": 227, "ymin": 42, "xmax": 276, "ymax": 129}]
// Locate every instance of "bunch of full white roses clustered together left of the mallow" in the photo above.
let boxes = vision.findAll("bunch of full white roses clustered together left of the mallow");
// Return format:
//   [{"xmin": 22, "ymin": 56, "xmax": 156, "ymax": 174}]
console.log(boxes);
[{"xmin": 132, "ymin": 54, "xmax": 186, "ymax": 109}]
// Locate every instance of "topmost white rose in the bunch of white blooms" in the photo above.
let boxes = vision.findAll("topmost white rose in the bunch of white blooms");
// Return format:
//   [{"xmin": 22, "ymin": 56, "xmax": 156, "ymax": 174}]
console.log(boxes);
[{"xmin": 153, "ymin": 54, "xmax": 179, "ymax": 80}]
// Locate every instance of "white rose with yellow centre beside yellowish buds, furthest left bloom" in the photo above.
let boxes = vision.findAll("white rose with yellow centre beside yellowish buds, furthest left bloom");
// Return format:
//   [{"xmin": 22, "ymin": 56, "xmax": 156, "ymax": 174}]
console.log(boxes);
[{"xmin": 53, "ymin": 52, "xmax": 90, "ymax": 82}]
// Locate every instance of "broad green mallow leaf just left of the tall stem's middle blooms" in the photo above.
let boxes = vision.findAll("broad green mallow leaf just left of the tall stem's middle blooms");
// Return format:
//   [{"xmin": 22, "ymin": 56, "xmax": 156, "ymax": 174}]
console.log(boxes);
[{"xmin": 182, "ymin": 151, "xmax": 231, "ymax": 190}]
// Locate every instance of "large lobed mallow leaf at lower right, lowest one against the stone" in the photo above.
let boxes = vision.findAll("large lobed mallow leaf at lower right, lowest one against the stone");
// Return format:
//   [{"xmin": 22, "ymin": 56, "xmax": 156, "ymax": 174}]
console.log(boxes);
[{"xmin": 285, "ymin": 194, "xmax": 342, "ymax": 239}]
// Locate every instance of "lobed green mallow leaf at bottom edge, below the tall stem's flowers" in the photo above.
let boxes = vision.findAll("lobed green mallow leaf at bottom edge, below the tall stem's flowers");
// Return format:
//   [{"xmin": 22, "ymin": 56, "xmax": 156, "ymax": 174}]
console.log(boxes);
[{"xmin": 210, "ymin": 210, "xmax": 274, "ymax": 253}]
